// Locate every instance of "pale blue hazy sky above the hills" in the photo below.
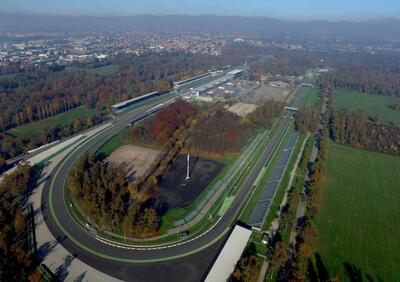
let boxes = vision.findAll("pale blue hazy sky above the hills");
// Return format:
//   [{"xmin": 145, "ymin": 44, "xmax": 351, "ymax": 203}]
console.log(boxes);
[{"xmin": 0, "ymin": 0, "xmax": 400, "ymax": 20}]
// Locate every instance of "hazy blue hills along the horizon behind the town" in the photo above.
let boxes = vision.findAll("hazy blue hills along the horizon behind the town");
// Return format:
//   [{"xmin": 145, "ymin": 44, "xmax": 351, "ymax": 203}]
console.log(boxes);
[{"xmin": 0, "ymin": 15, "xmax": 400, "ymax": 41}]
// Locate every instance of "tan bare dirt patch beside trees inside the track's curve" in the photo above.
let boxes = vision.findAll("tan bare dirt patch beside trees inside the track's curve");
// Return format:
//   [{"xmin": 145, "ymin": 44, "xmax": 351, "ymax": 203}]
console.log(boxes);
[{"xmin": 107, "ymin": 145, "xmax": 159, "ymax": 177}]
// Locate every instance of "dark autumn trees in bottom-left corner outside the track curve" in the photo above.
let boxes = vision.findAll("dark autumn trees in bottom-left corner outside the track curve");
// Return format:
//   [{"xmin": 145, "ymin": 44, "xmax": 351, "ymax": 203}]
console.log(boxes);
[{"xmin": 0, "ymin": 165, "xmax": 41, "ymax": 281}]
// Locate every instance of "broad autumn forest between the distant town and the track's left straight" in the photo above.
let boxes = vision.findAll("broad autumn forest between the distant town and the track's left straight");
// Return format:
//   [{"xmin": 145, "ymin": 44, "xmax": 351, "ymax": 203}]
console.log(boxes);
[{"xmin": 0, "ymin": 47, "xmax": 255, "ymax": 134}]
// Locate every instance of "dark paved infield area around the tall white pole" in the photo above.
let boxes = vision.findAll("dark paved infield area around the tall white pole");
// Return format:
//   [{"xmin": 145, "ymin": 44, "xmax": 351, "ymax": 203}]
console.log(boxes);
[{"xmin": 157, "ymin": 156, "xmax": 224, "ymax": 209}]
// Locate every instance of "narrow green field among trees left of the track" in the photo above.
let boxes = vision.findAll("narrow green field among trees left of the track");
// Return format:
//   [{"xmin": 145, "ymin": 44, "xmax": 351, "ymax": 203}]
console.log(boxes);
[{"xmin": 9, "ymin": 106, "xmax": 98, "ymax": 139}]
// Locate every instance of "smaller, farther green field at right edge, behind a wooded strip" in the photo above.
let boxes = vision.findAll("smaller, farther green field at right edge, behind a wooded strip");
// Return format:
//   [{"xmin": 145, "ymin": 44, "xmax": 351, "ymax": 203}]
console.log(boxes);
[{"xmin": 333, "ymin": 89, "xmax": 400, "ymax": 125}]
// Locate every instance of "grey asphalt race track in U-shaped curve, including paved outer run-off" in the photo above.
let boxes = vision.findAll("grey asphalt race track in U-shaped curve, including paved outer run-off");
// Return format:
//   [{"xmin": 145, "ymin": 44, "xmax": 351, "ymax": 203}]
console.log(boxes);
[{"xmin": 42, "ymin": 87, "xmax": 310, "ymax": 281}]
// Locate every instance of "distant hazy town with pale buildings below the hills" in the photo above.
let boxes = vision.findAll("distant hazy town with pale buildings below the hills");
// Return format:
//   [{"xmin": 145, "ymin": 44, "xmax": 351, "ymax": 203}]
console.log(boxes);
[{"xmin": 0, "ymin": 32, "xmax": 400, "ymax": 69}]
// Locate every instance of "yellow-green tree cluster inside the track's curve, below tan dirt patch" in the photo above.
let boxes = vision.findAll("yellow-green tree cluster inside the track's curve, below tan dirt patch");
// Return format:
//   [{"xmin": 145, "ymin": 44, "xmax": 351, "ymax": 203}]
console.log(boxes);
[{"xmin": 68, "ymin": 153, "xmax": 158, "ymax": 237}]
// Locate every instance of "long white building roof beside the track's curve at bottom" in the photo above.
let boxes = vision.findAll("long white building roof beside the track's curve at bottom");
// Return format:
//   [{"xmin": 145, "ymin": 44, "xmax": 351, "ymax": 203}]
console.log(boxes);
[{"xmin": 205, "ymin": 225, "xmax": 251, "ymax": 282}]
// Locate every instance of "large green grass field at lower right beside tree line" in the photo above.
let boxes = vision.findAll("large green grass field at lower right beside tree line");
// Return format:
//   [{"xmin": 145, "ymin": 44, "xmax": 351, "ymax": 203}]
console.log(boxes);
[{"xmin": 315, "ymin": 144, "xmax": 400, "ymax": 281}]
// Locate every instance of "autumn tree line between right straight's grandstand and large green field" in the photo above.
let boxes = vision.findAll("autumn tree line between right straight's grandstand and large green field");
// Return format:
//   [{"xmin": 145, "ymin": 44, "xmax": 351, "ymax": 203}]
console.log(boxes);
[{"xmin": 267, "ymin": 102, "xmax": 338, "ymax": 282}]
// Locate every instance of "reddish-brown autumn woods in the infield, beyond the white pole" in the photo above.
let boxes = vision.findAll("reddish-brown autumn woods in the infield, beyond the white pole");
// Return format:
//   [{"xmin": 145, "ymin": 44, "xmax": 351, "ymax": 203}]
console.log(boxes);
[{"xmin": 131, "ymin": 100, "xmax": 284, "ymax": 158}]
